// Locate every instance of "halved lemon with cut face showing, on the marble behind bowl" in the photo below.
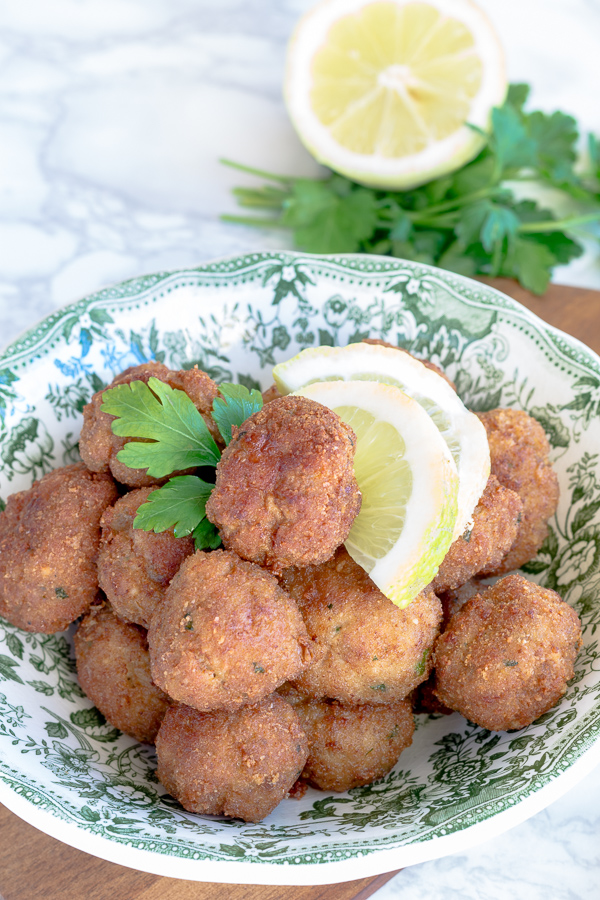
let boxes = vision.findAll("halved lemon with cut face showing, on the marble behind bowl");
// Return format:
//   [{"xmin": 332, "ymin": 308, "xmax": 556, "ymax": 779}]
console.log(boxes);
[{"xmin": 284, "ymin": 0, "xmax": 506, "ymax": 190}]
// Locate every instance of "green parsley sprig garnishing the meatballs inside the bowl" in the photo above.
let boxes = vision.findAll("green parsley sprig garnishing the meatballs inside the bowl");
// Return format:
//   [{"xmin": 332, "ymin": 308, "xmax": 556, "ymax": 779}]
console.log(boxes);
[{"xmin": 102, "ymin": 378, "xmax": 263, "ymax": 550}]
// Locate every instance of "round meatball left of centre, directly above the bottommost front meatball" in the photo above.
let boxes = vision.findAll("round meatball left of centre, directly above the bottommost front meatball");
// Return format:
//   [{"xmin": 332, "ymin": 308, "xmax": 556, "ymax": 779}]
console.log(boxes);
[{"xmin": 148, "ymin": 550, "xmax": 312, "ymax": 710}]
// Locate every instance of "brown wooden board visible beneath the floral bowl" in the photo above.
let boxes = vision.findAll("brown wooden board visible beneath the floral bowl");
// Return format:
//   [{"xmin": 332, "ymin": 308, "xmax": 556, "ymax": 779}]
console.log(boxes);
[{"xmin": 0, "ymin": 279, "xmax": 600, "ymax": 900}]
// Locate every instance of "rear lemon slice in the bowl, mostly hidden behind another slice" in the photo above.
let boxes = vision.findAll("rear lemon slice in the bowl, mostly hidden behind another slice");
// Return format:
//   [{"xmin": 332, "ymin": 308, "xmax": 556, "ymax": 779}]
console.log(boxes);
[{"xmin": 273, "ymin": 343, "xmax": 490, "ymax": 540}]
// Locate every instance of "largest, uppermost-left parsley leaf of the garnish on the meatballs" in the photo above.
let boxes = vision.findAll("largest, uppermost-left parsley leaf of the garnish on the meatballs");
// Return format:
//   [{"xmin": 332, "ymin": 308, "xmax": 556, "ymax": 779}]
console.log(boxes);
[{"xmin": 102, "ymin": 378, "xmax": 220, "ymax": 478}]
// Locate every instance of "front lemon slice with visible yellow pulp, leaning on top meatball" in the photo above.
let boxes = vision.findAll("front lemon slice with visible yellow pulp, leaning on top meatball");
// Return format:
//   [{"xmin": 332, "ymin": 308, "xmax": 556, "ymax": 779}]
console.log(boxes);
[{"xmin": 295, "ymin": 381, "xmax": 458, "ymax": 607}]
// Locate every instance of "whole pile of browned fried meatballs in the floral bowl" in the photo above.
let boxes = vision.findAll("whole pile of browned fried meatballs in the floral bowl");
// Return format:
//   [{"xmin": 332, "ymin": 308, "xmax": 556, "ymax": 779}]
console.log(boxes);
[{"xmin": 0, "ymin": 352, "xmax": 581, "ymax": 822}]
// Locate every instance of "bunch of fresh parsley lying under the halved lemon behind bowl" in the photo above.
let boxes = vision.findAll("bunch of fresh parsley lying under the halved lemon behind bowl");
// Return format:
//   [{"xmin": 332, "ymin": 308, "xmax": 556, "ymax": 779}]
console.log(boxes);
[{"xmin": 222, "ymin": 84, "xmax": 600, "ymax": 294}]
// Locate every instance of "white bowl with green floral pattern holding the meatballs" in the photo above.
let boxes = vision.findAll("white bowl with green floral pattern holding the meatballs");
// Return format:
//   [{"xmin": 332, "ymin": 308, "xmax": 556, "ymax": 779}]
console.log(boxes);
[{"xmin": 0, "ymin": 253, "xmax": 600, "ymax": 884}]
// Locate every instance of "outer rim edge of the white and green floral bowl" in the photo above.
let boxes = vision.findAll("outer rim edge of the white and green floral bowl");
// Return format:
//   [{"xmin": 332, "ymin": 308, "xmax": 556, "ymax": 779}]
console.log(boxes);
[{"xmin": 0, "ymin": 251, "xmax": 600, "ymax": 885}]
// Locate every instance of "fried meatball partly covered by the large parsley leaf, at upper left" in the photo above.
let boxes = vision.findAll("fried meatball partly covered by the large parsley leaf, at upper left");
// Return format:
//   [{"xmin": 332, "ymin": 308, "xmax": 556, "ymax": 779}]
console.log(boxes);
[{"xmin": 79, "ymin": 362, "xmax": 222, "ymax": 487}]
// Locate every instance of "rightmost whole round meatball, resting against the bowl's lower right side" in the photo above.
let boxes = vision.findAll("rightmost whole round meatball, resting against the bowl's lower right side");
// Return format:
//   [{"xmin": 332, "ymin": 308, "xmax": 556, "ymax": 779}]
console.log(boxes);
[{"xmin": 434, "ymin": 575, "xmax": 581, "ymax": 731}]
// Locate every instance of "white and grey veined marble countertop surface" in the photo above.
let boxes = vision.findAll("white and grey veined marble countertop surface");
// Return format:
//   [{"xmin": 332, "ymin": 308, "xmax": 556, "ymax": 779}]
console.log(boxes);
[{"xmin": 0, "ymin": 0, "xmax": 600, "ymax": 900}]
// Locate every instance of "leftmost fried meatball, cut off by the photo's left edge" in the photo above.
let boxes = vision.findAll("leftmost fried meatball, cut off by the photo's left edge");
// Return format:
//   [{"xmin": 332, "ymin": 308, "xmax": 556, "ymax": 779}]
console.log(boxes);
[{"xmin": 0, "ymin": 463, "xmax": 117, "ymax": 634}]
